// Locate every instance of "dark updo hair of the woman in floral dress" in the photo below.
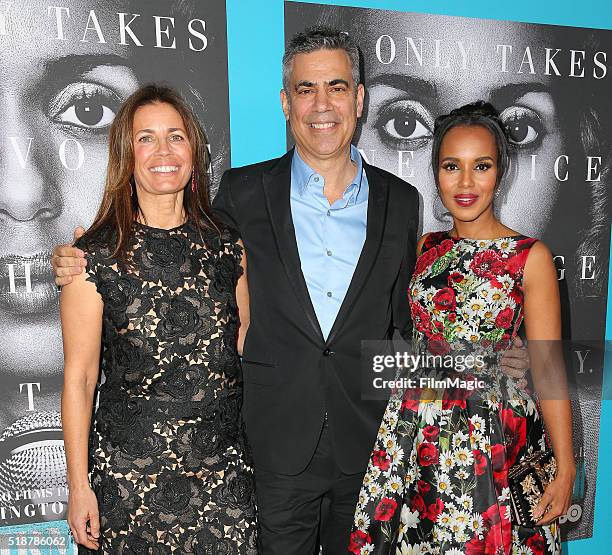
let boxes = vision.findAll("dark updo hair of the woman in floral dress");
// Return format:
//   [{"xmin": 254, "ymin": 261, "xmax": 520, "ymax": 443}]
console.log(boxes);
[{"xmin": 431, "ymin": 100, "xmax": 510, "ymax": 188}]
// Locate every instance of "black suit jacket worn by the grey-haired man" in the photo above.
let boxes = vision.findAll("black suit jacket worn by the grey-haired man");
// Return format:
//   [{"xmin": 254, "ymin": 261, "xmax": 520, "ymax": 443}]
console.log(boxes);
[{"xmin": 213, "ymin": 151, "xmax": 419, "ymax": 475}]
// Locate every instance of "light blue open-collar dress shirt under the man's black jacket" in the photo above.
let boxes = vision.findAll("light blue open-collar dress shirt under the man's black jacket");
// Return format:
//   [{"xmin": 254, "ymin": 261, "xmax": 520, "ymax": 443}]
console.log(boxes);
[{"xmin": 291, "ymin": 145, "xmax": 369, "ymax": 339}]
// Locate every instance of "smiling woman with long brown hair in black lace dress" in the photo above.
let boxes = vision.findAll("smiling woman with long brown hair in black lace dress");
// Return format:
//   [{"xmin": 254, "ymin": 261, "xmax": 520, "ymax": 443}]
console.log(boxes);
[{"xmin": 61, "ymin": 85, "xmax": 256, "ymax": 554}]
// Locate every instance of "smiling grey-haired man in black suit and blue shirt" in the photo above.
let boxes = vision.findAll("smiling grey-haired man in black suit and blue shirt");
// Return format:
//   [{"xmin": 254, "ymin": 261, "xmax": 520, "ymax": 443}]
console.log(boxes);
[{"xmin": 213, "ymin": 28, "xmax": 419, "ymax": 555}]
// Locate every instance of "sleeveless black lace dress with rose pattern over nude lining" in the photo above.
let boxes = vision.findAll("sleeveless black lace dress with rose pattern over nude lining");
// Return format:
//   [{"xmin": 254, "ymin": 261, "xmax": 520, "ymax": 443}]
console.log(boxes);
[{"xmin": 78, "ymin": 223, "xmax": 257, "ymax": 555}]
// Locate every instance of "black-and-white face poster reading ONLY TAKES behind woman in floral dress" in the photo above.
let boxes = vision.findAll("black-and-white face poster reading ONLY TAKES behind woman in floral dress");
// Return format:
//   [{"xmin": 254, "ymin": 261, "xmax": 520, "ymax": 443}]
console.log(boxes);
[{"xmin": 285, "ymin": 2, "xmax": 612, "ymax": 538}]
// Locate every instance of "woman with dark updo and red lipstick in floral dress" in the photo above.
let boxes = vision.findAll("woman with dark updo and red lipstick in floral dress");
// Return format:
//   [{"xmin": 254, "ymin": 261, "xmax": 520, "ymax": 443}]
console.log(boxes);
[{"xmin": 348, "ymin": 102, "xmax": 575, "ymax": 555}]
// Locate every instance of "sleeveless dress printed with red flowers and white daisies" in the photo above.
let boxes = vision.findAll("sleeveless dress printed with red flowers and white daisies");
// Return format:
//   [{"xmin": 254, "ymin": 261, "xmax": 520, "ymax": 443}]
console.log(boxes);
[{"xmin": 348, "ymin": 232, "xmax": 561, "ymax": 555}]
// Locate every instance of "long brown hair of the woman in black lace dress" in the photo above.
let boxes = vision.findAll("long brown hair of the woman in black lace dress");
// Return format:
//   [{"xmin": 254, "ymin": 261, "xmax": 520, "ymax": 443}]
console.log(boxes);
[{"xmin": 86, "ymin": 83, "xmax": 219, "ymax": 262}]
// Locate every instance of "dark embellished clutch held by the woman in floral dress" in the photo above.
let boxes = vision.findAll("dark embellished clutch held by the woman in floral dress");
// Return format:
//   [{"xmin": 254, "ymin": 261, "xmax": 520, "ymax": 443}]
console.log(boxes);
[{"xmin": 508, "ymin": 449, "xmax": 557, "ymax": 528}]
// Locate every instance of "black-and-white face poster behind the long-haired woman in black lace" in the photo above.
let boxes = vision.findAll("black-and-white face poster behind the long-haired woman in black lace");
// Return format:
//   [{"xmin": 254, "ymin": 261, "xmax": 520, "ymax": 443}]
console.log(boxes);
[{"xmin": 0, "ymin": 0, "xmax": 229, "ymax": 525}]
